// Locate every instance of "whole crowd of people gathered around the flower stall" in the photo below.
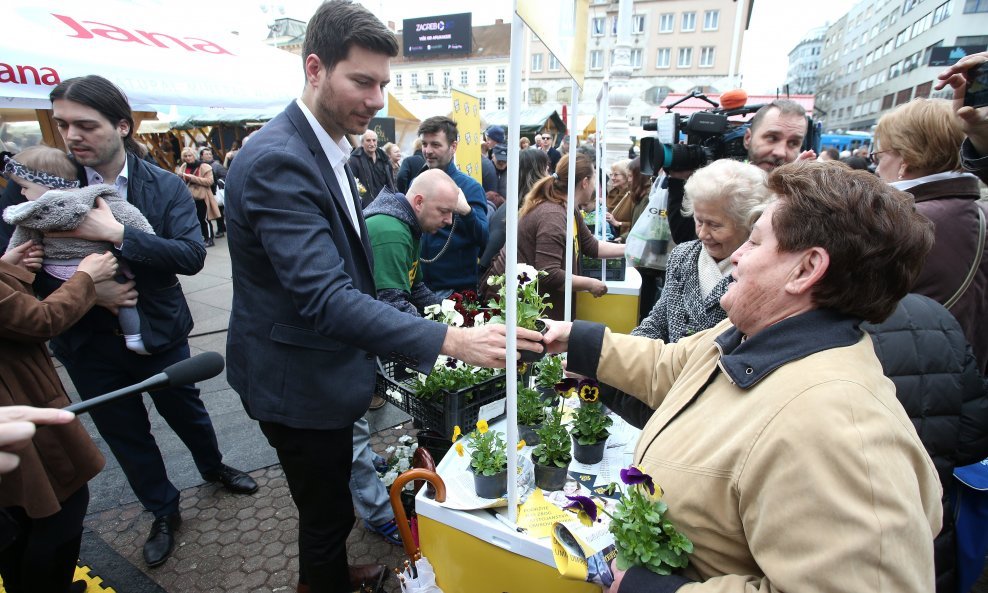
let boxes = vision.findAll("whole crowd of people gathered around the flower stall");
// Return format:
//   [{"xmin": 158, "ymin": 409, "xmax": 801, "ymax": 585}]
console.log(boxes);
[{"xmin": 0, "ymin": 0, "xmax": 988, "ymax": 593}]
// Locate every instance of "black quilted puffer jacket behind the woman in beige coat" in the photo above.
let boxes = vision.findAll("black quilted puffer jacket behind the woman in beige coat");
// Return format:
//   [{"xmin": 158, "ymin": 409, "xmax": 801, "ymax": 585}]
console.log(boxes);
[{"xmin": 862, "ymin": 294, "xmax": 988, "ymax": 593}]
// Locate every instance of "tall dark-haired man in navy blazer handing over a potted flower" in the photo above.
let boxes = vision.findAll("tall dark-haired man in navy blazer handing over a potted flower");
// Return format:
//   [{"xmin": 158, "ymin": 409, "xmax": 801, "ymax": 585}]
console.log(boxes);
[{"xmin": 226, "ymin": 0, "xmax": 542, "ymax": 592}]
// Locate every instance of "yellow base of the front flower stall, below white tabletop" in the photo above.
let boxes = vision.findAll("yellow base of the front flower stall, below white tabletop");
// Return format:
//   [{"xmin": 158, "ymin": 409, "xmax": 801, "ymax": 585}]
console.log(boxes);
[{"xmin": 418, "ymin": 514, "xmax": 600, "ymax": 593}]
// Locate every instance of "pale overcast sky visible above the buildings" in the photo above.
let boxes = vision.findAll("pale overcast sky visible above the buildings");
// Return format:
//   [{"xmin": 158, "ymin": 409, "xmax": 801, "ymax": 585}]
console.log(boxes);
[{"xmin": 218, "ymin": 0, "xmax": 860, "ymax": 93}]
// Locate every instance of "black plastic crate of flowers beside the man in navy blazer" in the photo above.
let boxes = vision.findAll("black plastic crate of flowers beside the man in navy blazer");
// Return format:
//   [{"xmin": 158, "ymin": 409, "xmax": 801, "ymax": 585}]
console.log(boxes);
[{"xmin": 374, "ymin": 361, "xmax": 506, "ymax": 438}]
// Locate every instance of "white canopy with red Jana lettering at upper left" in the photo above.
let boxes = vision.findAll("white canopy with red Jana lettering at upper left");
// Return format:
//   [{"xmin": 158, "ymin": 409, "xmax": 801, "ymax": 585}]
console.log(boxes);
[{"xmin": 0, "ymin": 0, "xmax": 305, "ymax": 111}]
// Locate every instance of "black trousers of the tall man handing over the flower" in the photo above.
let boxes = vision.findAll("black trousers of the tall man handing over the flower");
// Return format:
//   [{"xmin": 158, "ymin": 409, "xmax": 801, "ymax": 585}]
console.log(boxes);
[{"xmin": 261, "ymin": 422, "xmax": 354, "ymax": 593}]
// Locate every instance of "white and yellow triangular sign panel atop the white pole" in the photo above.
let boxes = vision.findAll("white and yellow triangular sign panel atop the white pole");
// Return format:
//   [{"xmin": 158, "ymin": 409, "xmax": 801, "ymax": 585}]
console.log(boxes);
[{"xmin": 516, "ymin": 0, "xmax": 590, "ymax": 89}]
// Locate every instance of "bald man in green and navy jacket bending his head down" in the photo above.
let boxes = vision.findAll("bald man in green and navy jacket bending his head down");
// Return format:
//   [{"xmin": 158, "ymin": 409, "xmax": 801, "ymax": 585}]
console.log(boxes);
[{"xmin": 364, "ymin": 169, "xmax": 470, "ymax": 316}]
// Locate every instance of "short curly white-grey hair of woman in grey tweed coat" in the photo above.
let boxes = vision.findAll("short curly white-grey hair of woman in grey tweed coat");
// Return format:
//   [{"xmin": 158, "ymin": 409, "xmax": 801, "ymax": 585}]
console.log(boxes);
[{"xmin": 683, "ymin": 159, "xmax": 774, "ymax": 230}]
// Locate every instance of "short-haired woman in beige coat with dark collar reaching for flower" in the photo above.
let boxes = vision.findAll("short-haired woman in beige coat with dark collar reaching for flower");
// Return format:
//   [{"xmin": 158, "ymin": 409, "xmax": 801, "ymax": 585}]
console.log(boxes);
[{"xmin": 546, "ymin": 161, "xmax": 942, "ymax": 593}]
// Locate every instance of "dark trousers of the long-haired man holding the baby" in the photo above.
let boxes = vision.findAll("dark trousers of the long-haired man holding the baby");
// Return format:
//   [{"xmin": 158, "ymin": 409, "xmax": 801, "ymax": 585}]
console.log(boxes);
[{"xmin": 57, "ymin": 333, "xmax": 223, "ymax": 517}]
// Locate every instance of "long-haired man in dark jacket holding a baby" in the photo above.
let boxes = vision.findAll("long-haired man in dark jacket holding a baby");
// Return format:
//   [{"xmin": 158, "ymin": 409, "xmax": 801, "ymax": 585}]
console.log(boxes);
[{"xmin": 0, "ymin": 76, "xmax": 257, "ymax": 567}]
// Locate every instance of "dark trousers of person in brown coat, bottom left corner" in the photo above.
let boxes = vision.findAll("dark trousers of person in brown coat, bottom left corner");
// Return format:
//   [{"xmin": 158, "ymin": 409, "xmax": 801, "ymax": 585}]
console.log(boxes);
[{"xmin": 0, "ymin": 486, "xmax": 89, "ymax": 593}]
